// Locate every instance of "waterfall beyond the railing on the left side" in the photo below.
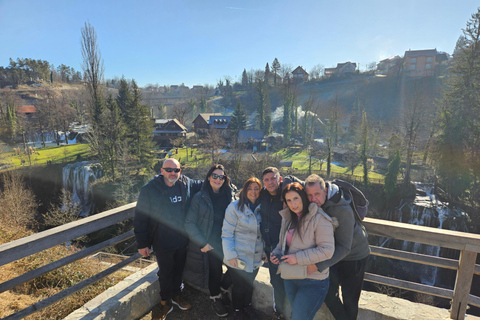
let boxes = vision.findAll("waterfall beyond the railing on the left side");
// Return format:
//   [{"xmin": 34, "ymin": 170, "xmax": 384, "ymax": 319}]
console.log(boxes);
[{"xmin": 62, "ymin": 161, "xmax": 102, "ymax": 217}]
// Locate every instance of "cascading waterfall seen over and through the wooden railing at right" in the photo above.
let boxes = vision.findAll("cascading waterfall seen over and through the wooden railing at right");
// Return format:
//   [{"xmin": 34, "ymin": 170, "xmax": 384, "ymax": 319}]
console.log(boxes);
[{"xmin": 379, "ymin": 182, "xmax": 469, "ymax": 285}]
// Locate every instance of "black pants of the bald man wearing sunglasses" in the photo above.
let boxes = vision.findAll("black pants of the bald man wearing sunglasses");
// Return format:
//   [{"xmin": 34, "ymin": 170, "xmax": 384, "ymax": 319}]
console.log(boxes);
[{"xmin": 153, "ymin": 244, "xmax": 187, "ymax": 300}]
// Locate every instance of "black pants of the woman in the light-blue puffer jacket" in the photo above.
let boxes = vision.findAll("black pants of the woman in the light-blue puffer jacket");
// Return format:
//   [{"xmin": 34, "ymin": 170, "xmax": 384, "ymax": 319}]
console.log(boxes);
[{"xmin": 228, "ymin": 268, "xmax": 258, "ymax": 310}]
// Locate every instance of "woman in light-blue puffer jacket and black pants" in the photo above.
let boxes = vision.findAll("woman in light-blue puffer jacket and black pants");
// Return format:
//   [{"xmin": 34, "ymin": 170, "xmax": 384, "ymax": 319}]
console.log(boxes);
[{"xmin": 222, "ymin": 178, "xmax": 264, "ymax": 320}]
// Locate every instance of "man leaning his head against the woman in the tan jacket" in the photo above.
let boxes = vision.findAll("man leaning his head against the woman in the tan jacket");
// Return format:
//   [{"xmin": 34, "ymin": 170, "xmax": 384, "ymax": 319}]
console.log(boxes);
[{"xmin": 305, "ymin": 174, "xmax": 370, "ymax": 320}]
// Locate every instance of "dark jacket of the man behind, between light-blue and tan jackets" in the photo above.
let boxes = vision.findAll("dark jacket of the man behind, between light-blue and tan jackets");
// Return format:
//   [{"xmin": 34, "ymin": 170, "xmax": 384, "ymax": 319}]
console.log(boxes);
[{"xmin": 260, "ymin": 176, "xmax": 304, "ymax": 252}]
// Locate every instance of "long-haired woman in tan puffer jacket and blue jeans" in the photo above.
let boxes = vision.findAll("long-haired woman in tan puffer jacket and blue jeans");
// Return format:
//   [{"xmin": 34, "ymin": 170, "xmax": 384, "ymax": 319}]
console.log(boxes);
[{"xmin": 270, "ymin": 182, "xmax": 335, "ymax": 320}]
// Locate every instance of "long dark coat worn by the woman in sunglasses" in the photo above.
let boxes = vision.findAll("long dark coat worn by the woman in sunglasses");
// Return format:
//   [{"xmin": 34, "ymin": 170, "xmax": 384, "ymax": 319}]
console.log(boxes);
[{"xmin": 183, "ymin": 185, "xmax": 236, "ymax": 288}]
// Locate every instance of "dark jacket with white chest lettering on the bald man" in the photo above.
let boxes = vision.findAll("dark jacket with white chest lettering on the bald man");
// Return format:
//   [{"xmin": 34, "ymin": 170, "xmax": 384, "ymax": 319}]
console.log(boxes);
[{"xmin": 133, "ymin": 175, "xmax": 203, "ymax": 250}]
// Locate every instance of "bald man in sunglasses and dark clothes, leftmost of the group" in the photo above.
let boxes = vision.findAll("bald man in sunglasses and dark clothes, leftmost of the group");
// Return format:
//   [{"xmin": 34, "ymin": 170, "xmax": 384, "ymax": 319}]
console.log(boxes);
[{"xmin": 134, "ymin": 158, "xmax": 202, "ymax": 320}]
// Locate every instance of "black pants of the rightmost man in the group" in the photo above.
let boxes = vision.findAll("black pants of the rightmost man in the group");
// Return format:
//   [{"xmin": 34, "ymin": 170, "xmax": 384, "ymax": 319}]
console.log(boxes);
[{"xmin": 325, "ymin": 257, "xmax": 368, "ymax": 320}]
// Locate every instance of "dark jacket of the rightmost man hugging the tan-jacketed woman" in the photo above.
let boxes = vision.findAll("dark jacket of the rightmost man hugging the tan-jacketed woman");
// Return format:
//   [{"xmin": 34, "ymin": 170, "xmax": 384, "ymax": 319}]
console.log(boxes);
[{"xmin": 316, "ymin": 183, "xmax": 370, "ymax": 271}]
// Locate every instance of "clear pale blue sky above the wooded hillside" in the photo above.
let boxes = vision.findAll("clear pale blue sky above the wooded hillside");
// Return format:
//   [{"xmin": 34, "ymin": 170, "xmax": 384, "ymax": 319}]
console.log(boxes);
[{"xmin": 0, "ymin": 0, "xmax": 480, "ymax": 87}]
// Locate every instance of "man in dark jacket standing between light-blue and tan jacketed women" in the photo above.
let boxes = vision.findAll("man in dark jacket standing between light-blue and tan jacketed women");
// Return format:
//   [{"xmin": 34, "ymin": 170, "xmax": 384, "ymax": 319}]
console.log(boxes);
[{"xmin": 260, "ymin": 167, "xmax": 303, "ymax": 319}]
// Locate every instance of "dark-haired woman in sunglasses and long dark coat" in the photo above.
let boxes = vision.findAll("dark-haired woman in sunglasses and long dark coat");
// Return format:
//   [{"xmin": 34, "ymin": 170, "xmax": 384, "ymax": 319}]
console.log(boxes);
[{"xmin": 184, "ymin": 164, "xmax": 236, "ymax": 317}]
